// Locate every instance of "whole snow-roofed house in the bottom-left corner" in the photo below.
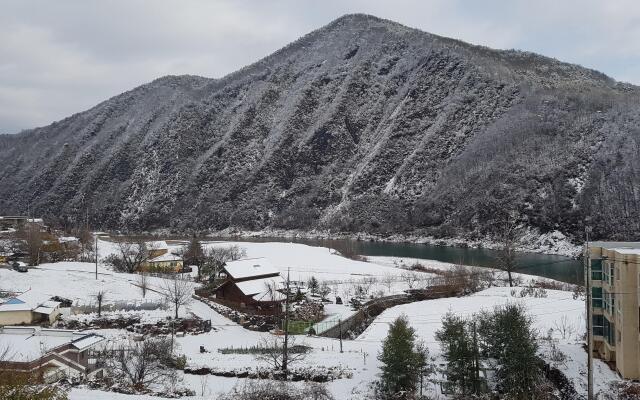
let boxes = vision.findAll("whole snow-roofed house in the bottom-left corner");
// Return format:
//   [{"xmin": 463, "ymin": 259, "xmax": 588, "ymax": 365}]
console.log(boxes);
[{"xmin": 0, "ymin": 326, "xmax": 105, "ymax": 382}]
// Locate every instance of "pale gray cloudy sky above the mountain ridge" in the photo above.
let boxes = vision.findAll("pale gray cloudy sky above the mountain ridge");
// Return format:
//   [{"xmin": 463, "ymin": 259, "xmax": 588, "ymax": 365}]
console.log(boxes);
[{"xmin": 0, "ymin": 0, "xmax": 640, "ymax": 133}]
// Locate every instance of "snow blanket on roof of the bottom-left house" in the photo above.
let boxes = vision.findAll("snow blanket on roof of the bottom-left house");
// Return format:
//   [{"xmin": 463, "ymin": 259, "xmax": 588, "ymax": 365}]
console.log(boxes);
[{"xmin": 0, "ymin": 327, "xmax": 104, "ymax": 362}]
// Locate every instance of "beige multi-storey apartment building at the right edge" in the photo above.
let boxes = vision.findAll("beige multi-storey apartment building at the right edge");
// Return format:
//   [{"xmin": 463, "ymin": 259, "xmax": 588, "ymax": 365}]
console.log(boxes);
[{"xmin": 585, "ymin": 242, "xmax": 640, "ymax": 379}]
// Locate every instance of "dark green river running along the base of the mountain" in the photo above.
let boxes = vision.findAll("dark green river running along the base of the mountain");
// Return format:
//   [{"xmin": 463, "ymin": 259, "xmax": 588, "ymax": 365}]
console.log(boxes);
[{"xmin": 211, "ymin": 237, "xmax": 584, "ymax": 284}]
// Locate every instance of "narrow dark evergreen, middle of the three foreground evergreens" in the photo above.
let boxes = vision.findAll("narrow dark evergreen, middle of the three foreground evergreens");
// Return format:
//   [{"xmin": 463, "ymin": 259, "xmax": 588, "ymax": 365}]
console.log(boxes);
[{"xmin": 436, "ymin": 312, "xmax": 480, "ymax": 395}]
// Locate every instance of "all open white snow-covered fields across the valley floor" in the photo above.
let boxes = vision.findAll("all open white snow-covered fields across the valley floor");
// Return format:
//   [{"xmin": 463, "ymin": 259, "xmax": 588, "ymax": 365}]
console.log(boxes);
[{"xmin": 0, "ymin": 241, "xmax": 616, "ymax": 400}]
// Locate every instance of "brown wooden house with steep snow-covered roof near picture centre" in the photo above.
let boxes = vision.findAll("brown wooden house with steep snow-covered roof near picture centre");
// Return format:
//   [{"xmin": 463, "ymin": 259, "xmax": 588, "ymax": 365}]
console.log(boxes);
[{"xmin": 216, "ymin": 258, "xmax": 285, "ymax": 315}]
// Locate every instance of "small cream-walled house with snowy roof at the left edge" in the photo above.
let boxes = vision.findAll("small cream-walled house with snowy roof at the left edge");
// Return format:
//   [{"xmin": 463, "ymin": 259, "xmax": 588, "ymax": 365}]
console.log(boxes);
[{"xmin": 0, "ymin": 290, "xmax": 60, "ymax": 326}]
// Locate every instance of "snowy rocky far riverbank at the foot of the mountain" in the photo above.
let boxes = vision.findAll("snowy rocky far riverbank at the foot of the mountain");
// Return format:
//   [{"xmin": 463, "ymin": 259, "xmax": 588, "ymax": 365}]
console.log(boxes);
[{"xmin": 198, "ymin": 228, "xmax": 582, "ymax": 258}]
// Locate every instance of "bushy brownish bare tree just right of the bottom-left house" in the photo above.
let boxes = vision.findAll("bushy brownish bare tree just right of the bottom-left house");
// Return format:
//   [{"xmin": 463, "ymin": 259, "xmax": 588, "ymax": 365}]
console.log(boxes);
[{"xmin": 106, "ymin": 338, "xmax": 174, "ymax": 390}]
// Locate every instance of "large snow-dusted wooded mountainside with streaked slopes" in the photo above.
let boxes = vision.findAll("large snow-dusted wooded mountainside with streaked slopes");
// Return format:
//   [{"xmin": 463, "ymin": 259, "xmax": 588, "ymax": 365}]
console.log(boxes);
[{"xmin": 0, "ymin": 15, "xmax": 640, "ymax": 240}]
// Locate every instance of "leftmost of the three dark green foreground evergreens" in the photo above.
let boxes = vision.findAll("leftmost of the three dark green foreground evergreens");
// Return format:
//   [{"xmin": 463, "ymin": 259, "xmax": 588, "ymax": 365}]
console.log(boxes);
[{"xmin": 378, "ymin": 315, "xmax": 428, "ymax": 399}]
